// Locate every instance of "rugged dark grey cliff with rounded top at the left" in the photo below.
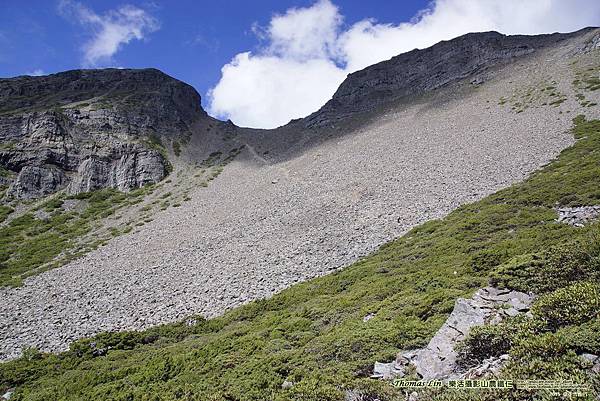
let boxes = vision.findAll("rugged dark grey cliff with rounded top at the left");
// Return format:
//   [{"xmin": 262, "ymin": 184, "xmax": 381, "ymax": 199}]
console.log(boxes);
[{"xmin": 0, "ymin": 69, "xmax": 207, "ymax": 199}]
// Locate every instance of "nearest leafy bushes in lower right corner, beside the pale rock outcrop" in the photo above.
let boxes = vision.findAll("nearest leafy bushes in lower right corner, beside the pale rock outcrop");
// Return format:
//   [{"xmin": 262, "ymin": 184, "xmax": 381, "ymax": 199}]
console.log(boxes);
[{"xmin": 450, "ymin": 278, "xmax": 600, "ymax": 401}]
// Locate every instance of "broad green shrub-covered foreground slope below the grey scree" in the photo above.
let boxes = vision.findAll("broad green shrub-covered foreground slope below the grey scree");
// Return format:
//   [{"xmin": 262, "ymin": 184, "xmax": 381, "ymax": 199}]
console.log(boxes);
[{"xmin": 0, "ymin": 117, "xmax": 600, "ymax": 401}]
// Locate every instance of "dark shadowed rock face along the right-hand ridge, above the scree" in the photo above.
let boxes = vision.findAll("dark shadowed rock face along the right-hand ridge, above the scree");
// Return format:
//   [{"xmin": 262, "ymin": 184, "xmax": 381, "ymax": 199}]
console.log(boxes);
[{"xmin": 304, "ymin": 28, "xmax": 591, "ymax": 127}]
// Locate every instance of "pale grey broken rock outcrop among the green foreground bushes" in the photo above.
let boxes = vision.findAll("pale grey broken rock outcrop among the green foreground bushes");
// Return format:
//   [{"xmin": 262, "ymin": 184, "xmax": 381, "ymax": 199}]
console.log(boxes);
[{"xmin": 373, "ymin": 287, "xmax": 534, "ymax": 380}]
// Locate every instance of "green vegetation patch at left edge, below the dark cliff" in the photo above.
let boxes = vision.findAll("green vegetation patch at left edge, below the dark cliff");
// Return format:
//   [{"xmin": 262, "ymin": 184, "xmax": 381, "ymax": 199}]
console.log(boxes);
[{"xmin": 0, "ymin": 188, "xmax": 154, "ymax": 285}]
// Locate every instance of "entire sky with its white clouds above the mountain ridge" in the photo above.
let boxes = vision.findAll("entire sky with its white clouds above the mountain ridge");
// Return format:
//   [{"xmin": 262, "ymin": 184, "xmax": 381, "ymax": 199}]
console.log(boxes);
[{"xmin": 0, "ymin": 0, "xmax": 600, "ymax": 128}]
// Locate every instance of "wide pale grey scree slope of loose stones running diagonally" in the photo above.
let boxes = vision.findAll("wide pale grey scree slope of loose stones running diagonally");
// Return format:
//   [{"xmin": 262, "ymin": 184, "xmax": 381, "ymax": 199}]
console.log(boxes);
[{"xmin": 0, "ymin": 36, "xmax": 600, "ymax": 359}]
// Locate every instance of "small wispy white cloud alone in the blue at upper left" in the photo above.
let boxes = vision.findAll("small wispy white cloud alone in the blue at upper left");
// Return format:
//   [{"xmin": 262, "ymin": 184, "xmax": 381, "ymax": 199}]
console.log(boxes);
[{"xmin": 59, "ymin": 0, "xmax": 160, "ymax": 67}]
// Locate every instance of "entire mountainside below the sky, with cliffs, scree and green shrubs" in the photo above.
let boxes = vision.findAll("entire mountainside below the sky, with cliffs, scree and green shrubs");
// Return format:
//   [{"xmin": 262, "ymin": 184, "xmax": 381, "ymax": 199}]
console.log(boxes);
[{"xmin": 0, "ymin": 28, "xmax": 600, "ymax": 401}]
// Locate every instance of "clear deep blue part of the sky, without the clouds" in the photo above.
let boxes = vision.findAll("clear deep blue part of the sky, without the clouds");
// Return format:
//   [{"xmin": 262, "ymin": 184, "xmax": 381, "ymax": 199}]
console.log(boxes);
[{"xmin": 0, "ymin": 0, "xmax": 427, "ymax": 101}]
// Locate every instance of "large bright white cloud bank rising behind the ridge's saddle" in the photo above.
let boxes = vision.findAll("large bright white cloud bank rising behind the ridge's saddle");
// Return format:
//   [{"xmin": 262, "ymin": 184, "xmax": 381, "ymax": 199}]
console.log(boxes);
[{"xmin": 209, "ymin": 0, "xmax": 600, "ymax": 128}]
